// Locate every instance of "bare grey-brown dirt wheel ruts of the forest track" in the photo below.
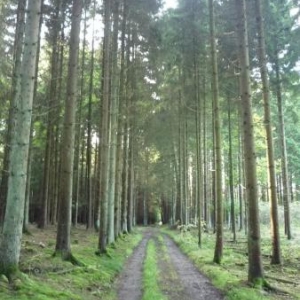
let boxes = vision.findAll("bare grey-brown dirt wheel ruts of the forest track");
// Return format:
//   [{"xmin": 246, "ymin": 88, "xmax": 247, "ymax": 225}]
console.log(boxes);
[{"xmin": 117, "ymin": 229, "xmax": 223, "ymax": 300}]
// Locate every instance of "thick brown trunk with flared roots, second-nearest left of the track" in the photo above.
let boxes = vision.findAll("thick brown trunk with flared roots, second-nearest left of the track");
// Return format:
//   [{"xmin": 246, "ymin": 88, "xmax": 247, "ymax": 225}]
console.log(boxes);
[{"xmin": 55, "ymin": 0, "xmax": 82, "ymax": 263}]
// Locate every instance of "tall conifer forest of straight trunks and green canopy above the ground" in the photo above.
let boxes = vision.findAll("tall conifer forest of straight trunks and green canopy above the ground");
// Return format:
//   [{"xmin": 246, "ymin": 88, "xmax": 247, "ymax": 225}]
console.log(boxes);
[{"xmin": 0, "ymin": 0, "xmax": 300, "ymax": 300}]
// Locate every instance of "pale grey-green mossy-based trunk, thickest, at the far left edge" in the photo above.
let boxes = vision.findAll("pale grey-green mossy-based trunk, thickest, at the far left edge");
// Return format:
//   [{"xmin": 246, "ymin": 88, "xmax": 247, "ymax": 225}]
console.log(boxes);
[{"xmin": 0, "ymin": 0, "xmax": 41, "ymax": 278}]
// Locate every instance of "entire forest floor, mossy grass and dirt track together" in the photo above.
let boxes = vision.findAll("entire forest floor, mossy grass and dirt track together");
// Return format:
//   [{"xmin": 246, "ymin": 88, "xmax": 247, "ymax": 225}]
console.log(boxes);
[{"xmin": 0, "ymin": 227, "xmax": 300, "ymax": 300}]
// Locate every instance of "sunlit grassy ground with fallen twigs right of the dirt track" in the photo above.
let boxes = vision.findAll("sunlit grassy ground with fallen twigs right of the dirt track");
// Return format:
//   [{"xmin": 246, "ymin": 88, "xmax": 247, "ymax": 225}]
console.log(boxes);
[{"xmin": 163, "ymin": 229, "xmax": 300, "ymax": 300}]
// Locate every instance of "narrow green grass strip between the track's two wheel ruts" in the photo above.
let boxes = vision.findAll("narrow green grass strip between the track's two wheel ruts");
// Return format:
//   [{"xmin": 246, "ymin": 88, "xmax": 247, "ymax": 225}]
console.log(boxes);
[{"xmin": 143, "ymin": 240, "xmax": 167, "ymax": 300}]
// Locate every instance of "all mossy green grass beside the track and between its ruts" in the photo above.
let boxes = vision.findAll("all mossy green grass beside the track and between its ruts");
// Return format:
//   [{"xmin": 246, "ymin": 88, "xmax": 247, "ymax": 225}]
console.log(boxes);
[{"xmin": 0, "ymin": 227, "xmax": 300, "ymax": 300}]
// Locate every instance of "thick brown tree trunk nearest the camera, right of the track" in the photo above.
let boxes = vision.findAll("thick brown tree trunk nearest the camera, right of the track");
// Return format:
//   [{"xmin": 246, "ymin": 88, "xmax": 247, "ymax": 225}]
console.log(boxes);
[{"xmin": 235, "ymin": 0, "xmax": 264, "ymax": 285}]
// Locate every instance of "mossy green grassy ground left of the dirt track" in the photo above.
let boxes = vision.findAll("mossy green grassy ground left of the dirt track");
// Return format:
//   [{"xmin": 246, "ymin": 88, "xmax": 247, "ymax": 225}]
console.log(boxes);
[{"xmin": 0, "ymin": 228, "xmax": 142, "ymax": 300}]
